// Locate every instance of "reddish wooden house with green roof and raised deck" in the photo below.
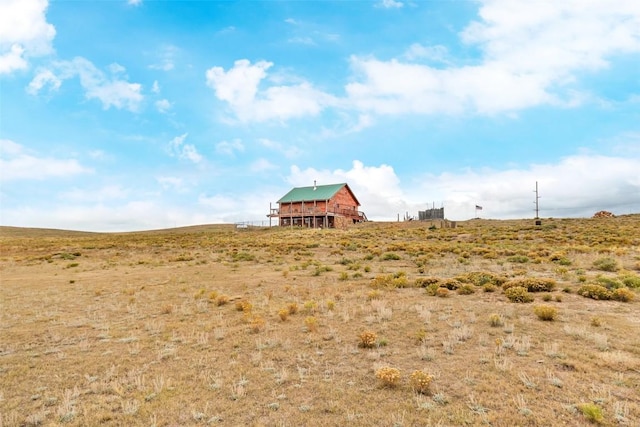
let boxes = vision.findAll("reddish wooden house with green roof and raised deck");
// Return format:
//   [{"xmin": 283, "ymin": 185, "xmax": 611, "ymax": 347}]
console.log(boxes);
[{"xmin": 268, "ymin": 182, "xmax": 367, "ymax": 228}]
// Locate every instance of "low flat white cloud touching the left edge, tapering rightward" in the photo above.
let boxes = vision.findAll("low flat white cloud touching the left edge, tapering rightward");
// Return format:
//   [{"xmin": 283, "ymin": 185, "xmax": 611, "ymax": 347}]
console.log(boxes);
[{"xmin": 0, "ymin": 139, "xmax": 91, "ymax": 182}]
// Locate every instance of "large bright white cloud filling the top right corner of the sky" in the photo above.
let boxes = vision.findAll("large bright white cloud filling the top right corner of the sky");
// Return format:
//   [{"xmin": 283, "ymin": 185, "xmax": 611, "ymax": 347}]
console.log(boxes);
[{"xmin": 462, "ymin": 0, "xmax": 640, "ymax": 74}]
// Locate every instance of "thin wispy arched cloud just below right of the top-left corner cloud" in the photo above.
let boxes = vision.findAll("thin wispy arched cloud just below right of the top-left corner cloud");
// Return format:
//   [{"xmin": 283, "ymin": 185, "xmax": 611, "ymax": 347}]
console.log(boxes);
[{"xmin": 27, "ymin": 57, "xmax": 144, "ymax": 112}]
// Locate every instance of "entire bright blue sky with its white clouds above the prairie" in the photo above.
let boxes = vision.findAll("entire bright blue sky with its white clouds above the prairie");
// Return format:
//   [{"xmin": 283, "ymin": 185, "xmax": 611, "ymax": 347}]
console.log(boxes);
[{"xmin": 0, "ymin": 0, "xmax": 640, "ymax": 231}]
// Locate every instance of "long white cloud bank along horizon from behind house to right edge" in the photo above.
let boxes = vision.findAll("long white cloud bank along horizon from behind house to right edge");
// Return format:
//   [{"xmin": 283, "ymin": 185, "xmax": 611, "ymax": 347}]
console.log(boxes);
[{"xmin": 287, "ymin": 155, "xmax": 640, "ymax": 220}]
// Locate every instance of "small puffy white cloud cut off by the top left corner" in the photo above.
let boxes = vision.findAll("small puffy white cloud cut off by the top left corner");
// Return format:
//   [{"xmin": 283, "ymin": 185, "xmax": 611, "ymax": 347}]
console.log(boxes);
[{"xmin": 0, "ymin": 0, "xmax": 56, "ymax": 74}]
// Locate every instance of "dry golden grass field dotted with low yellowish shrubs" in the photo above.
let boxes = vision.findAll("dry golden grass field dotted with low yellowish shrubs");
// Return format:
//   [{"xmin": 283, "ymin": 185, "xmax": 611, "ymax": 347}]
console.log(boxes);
[{"xmin": 0, "ymin": 215, "xmax": 640, "ymax": 427}]
